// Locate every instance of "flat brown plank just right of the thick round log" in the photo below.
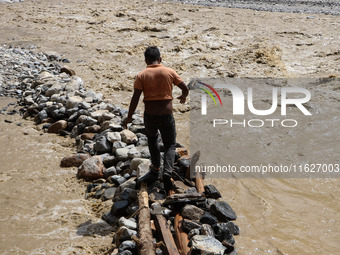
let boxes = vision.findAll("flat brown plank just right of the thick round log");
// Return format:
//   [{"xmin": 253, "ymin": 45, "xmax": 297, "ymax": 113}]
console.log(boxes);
[{"xmin": 155, "ymin": 215, "xmax": 180, "ymax": 255}]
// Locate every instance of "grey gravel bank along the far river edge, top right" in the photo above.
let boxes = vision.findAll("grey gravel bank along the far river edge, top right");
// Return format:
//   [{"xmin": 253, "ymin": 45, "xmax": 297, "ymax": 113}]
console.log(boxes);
[{"xmin": 161, "ymin": 0, "xmax": 340, "ymax": 15}]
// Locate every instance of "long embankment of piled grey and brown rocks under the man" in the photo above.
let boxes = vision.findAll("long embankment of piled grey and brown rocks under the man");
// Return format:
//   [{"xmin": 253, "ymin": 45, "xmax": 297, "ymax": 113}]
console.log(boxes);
[{"xmin": 0, "ymin": 44, "xmax": 239, "ymax": 254}]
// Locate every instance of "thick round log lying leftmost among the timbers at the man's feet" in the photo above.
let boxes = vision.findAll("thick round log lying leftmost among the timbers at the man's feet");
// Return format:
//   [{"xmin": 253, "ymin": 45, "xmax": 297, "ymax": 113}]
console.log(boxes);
[{"xmin": 138, "ymin": 184, "xmax": 156, "ymax": 255}]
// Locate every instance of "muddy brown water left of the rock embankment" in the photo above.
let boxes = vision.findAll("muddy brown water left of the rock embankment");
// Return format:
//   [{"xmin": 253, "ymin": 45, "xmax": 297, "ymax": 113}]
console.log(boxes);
[{"xmin": 0, "ymin": 98, "xmax": 112, "ymax": 254}]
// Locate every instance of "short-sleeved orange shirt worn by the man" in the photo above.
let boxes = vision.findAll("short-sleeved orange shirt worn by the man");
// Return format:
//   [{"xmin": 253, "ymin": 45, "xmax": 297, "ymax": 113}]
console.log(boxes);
[{"xmin": 134, "ymin": 64, "xmax": 183, "ymax": 101}]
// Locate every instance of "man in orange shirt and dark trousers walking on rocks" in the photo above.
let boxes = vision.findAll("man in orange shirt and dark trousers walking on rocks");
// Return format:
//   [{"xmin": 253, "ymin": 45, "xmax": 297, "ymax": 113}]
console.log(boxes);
[{"xmin": 123, "ymin": 47, "xmax": 189, "ymax": 192}]
